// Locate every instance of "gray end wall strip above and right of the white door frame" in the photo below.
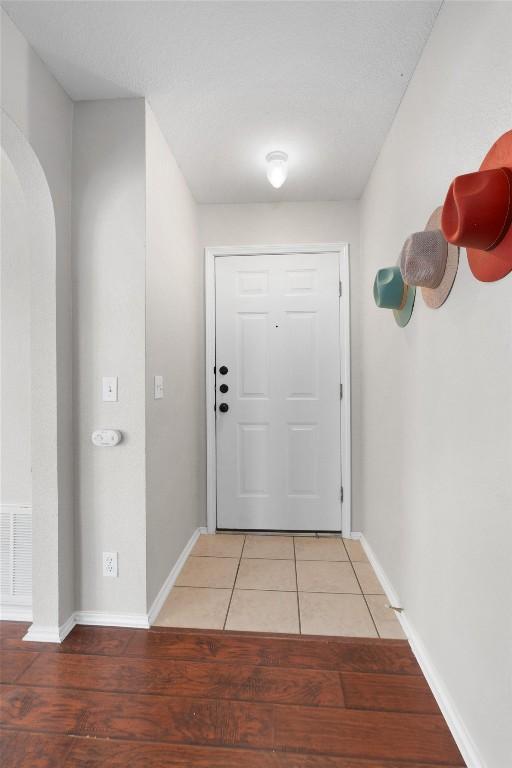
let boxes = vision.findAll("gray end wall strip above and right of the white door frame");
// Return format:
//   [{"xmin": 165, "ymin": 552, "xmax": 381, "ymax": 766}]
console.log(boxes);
[{"xmin": 198, "ymin": 200, "xmax": 361, "ymax": 531}]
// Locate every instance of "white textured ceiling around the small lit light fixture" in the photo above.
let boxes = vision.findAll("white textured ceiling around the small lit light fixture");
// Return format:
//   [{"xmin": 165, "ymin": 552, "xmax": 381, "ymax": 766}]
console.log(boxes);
[{"xmin": 2, "ymin": 0, "xmax": 440, "ymax": 202}]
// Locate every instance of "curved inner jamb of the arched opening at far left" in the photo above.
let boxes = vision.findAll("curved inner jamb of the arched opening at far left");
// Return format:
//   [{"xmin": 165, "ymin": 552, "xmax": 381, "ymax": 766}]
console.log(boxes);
[{"xmin": 1, "ymin": 110, "xmax": 62, "ymax": 642}]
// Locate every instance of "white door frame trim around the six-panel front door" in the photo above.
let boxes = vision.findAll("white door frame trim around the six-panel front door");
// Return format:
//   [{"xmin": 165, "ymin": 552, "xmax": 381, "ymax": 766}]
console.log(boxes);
[{"xmin": 204, "ymin": 243, "xmax": 352, "ymax": 537}]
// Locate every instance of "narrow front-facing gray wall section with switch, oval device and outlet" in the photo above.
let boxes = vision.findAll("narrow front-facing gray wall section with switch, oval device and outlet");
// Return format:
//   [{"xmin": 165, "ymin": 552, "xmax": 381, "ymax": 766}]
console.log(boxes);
[{"xmin": 73, "ymin": 99, "xmax": 146, "ymax": 614}]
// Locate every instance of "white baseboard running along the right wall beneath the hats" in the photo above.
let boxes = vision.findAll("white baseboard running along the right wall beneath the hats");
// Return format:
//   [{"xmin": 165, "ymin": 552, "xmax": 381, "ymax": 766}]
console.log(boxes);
[{"xmin": 360, "ymin": 534, "xmax": 486, "ymax": 768}]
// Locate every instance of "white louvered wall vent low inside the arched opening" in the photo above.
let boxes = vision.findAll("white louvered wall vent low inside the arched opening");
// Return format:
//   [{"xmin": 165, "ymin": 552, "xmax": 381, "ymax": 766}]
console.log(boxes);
[{"xmin": 0, "ymin": 504, "xmax": 32, "ymax": 605}]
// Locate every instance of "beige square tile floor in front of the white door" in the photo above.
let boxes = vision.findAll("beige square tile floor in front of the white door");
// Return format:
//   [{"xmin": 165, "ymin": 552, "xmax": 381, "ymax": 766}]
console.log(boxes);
[{"xmin": 155, "ymin": 533, "xmax": 404, "ymax": 638}]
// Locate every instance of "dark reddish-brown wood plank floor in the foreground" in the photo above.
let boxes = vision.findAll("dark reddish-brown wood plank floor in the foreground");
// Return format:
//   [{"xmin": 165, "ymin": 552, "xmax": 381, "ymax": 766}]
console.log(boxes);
[{"xmin": 0, "ymin": 622, "xmax": 464, "ymax": 768}]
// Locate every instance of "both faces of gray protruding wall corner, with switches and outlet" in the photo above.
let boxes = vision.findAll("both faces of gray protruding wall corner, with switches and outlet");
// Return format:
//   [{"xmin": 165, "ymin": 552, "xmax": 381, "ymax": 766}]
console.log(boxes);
[{"xmin": 73, "ymin": 99, "xmax": 206, "ymax": 623}]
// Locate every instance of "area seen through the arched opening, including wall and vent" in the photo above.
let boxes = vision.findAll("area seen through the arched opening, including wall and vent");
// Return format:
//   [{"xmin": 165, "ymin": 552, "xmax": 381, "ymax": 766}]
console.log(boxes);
[{"xmin": 0, "ymin": 149, "xmax": 32, "ymax": 621}]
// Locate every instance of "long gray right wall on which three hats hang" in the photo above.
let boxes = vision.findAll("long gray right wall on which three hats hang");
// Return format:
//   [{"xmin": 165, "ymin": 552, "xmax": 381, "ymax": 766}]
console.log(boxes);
[{"xmin": 357, "ymin": 3, "xmax": 512, "ymax": 768}]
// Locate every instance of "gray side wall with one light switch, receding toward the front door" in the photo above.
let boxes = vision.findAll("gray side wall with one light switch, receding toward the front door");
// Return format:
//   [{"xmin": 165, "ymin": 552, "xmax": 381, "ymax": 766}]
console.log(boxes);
[{"xmin": 146, "ymin": 106, "xmax": 206, "ymax": 608}]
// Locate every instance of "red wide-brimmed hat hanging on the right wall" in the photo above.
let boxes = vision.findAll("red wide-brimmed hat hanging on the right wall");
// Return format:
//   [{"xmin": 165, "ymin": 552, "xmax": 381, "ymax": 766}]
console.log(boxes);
[{"xmin": 441, "ymin": 131, "xmax": 512, "ymax": 283}]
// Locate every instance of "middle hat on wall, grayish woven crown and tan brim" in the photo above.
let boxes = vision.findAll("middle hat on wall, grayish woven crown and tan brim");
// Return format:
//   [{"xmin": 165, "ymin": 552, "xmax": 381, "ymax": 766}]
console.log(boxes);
[{"xmin": 400, "ymin": 207, "xmax": 459, "ymax": 309}]
